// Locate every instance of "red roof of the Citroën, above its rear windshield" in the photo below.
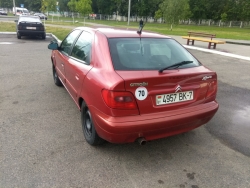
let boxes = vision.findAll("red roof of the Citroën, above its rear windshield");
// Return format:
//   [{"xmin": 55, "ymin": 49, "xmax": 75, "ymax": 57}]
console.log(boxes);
[{"xmin": 75, "ymin": 27, "xmax": 171, "ymax": 38}]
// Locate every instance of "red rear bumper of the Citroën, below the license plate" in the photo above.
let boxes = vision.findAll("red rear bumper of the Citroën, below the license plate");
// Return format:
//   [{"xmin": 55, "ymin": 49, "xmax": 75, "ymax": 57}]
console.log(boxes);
[{"xmin": 89, "ymin": 101, "xmax": 219, "ymax": 143}]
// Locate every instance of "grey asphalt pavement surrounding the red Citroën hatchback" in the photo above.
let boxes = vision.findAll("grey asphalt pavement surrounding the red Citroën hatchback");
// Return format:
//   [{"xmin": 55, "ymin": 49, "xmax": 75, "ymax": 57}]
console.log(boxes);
[{"xmin": 0, "ymin": 35, "xmax": 250, "ymax": 188}]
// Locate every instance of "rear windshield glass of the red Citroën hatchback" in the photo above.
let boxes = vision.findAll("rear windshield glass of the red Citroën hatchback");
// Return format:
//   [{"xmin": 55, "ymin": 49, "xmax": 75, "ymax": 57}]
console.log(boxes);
[{"xmin": 109, "ymin": 38, "xmax": 200, "ymax": 70}]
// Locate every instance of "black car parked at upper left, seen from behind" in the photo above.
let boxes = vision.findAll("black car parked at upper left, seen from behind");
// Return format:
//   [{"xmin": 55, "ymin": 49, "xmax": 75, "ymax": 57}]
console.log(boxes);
[{"xmin": 15, "ymin": 15, "xmax": 46, "ymax": 39}]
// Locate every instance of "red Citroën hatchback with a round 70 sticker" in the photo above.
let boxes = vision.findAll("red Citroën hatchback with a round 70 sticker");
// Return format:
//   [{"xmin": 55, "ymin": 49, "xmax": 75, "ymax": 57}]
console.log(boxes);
[{"xmin": 48, "ymin": 27, "xmax": 219, "ymax": 145}]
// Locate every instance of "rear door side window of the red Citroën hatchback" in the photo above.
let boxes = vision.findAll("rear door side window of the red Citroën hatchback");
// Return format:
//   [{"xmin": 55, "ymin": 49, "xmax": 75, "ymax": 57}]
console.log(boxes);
[{"xmin": 71, "ymin": 31, "xmax": 92, "ymax": 64}]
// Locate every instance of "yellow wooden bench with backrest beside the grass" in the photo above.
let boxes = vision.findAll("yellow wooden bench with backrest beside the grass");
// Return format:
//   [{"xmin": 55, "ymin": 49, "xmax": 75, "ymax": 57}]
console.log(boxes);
[{"xmin": 182, "ymin": 31, "xmax": 225, "ymax": 49}]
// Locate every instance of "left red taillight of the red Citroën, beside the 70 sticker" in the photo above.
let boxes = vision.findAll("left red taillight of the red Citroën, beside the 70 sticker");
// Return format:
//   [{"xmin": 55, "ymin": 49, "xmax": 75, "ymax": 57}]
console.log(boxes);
[{"xmin": 102, "ymin": 89, "xmax": 137, "ymax": 110}]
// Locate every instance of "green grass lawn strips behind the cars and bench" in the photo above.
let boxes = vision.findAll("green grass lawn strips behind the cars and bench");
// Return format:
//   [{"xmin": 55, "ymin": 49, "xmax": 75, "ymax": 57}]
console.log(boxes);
[{"xmin": 0, "ymin": 16, "xmax": 250, "ymax": 40}]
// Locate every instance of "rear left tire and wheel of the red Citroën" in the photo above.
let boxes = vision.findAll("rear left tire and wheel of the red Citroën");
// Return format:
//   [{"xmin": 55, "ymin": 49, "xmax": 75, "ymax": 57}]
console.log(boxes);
[{"xmin": 81, "ymin": 101, "xmax": 104, "ymax": 146}]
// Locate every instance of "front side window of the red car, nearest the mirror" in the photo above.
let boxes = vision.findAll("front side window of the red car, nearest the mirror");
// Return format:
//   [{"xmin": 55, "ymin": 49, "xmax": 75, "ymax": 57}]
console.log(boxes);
[{"xmin": 60, "ymin": 30, "xmax": 81, "ymax": 55}]
